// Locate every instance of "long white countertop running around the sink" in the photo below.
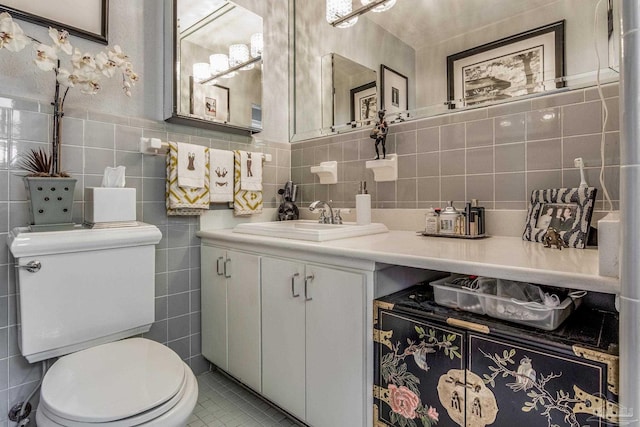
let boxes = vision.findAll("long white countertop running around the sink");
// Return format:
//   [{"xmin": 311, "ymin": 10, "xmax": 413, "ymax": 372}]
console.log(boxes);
[{"xmin": 197, "ymin": 229, "xmax": 620, "ymax": 293}]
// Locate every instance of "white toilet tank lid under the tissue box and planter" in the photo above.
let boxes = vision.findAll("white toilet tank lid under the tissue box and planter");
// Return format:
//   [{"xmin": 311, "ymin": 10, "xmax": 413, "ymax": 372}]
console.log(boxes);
[{"xmin": 7, "ymin": 222, "xmax": 162, "ymax": 258}]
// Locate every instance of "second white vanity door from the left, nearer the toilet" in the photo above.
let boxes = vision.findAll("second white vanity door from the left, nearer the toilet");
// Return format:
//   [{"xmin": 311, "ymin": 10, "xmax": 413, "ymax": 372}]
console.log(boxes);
[{"xmin": 226, "ymin": 251, "xmax": 261, "ymax": 392}]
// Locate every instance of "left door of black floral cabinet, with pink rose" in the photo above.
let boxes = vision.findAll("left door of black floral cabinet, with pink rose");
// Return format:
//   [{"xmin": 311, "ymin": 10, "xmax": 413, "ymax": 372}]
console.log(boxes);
[{"xmin": 373, "ymin": 303, "xmax": 465, "ymax": 427}]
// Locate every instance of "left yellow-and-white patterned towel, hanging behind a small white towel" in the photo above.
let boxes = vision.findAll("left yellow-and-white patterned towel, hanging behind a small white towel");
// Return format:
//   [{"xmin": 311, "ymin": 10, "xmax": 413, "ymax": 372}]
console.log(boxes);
[{"xmin": 166, "ymin": 142, "xmax": 209, "ymax": 215}]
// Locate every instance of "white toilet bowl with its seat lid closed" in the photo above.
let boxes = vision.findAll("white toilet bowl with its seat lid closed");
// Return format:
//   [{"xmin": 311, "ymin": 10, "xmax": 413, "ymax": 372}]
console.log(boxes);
[{"xmin": 36, "ymin": 338, "xmax": 198, "ymax": 427}]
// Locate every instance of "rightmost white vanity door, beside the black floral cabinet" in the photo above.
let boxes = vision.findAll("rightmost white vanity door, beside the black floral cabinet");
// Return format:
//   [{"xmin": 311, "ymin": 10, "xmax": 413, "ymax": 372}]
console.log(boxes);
[{"xmin": 305, "ymin": 264, "xmax": 368, "ymax": 427}]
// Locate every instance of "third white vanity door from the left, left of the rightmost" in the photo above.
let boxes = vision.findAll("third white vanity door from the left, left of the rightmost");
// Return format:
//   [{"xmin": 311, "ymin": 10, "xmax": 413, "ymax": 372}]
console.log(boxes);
[{"xmin": 262, "ymin": 257, "xmax": 305, "ymax": 419}]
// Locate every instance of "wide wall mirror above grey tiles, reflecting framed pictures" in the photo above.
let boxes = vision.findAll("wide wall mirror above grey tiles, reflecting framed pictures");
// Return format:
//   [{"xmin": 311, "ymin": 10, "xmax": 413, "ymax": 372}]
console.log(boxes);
[{"xmin": 292, "ymin": 0, "xmax": 619, "ymax": 141}]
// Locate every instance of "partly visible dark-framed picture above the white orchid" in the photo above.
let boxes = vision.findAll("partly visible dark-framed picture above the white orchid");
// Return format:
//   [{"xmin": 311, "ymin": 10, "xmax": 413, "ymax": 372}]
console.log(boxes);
[{"xmin": 0, "ymin": 0, "xmax": 109, "ymax": 44}]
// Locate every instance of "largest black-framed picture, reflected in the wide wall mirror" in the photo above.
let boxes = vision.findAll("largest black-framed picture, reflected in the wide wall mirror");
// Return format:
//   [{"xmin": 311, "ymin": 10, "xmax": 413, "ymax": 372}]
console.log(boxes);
[{"xmin": 447, "ymin": 20, "xmax": 565, "ymax": 108}]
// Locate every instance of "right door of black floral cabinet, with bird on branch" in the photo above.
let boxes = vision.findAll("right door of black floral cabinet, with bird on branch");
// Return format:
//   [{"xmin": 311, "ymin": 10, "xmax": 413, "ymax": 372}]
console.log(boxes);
[{"xmin": 468, "ymin": 333, "xmax": 620, "ymax": 427}]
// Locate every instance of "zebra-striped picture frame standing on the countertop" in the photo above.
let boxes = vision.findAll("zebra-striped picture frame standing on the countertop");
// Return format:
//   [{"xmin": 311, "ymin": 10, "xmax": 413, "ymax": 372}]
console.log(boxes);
[{"xmin": 522, "ymin": 187, "xmax": 597, "ymax": 249}]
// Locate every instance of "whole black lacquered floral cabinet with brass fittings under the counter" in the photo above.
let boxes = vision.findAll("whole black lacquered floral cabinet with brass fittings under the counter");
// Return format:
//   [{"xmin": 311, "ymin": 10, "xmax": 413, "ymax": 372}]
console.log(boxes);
[{"xmin": 374, "ymin": 286, "xmax": 623, "ymax": 427}]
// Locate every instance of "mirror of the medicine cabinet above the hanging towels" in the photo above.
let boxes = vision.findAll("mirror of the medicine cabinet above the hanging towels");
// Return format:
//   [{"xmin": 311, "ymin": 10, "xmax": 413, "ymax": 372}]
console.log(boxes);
[{"xmin": 165, "ymin": 0, "xmax": 264, "ymax": 135}]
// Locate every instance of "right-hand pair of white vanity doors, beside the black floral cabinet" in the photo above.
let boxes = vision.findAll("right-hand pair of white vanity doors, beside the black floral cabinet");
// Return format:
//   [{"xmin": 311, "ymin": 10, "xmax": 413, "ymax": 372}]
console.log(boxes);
[{"xmin": 261, "ymin": 257, "xmax": 367, "ymax": 427}]
